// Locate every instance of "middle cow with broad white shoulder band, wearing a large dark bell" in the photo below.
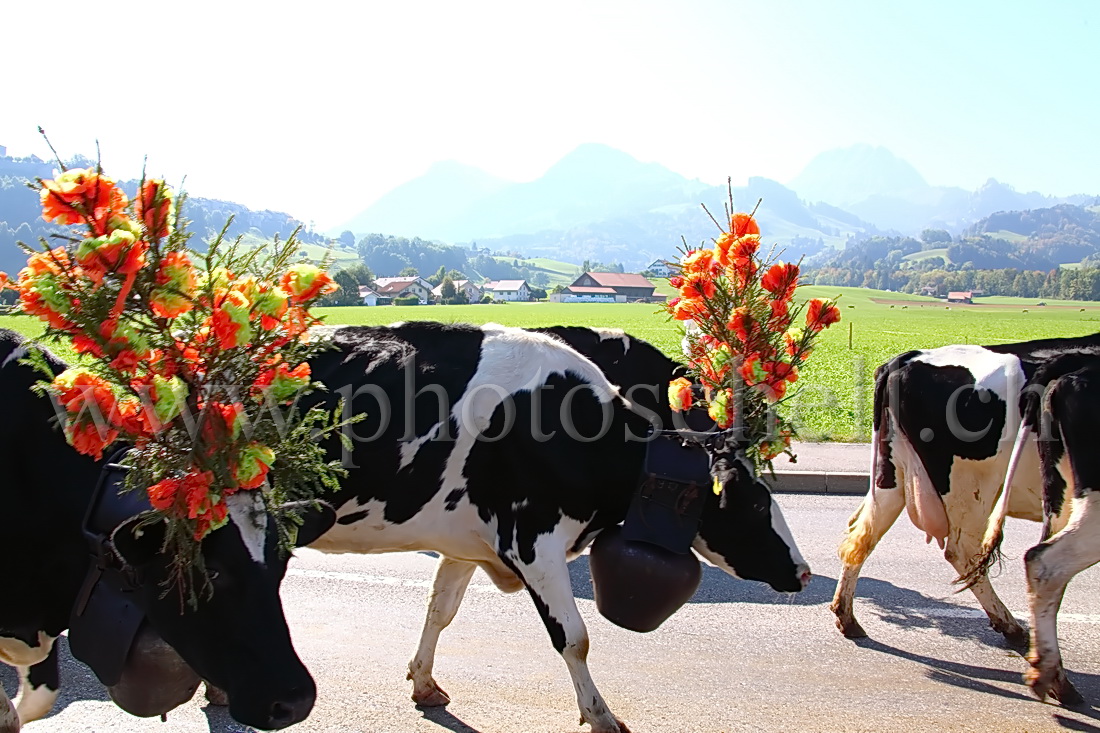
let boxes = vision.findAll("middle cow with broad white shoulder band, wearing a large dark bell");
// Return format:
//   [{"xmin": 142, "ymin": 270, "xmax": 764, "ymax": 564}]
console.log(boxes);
[{"xmin": 301, "ymin": 324, "xmax": 810, "ymax": 733}]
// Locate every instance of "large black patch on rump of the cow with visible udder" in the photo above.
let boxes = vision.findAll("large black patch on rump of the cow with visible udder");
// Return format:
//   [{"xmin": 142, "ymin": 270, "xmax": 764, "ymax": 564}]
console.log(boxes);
[{"xmin": 887, "ymin": 361, "xmax": 1008, "ymax": 495}]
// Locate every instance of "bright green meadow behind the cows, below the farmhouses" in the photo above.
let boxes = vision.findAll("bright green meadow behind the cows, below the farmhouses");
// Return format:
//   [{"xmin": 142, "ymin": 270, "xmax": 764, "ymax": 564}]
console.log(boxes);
[{"xmin": 8, "ymin": 286, "xmax": 1100, "ymax": 441}]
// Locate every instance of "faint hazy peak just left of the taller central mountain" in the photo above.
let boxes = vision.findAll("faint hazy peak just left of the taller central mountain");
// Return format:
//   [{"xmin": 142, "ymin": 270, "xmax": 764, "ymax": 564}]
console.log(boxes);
[{"xmin": 330, "ymin": 161, "xmax": 512, "ymax": 239}]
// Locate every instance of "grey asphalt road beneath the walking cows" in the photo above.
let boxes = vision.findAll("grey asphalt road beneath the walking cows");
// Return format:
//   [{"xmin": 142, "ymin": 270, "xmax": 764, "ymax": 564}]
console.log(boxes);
[{"xmin": 8, "ymin": 494, "xmax": 1100, "ymax": 733}]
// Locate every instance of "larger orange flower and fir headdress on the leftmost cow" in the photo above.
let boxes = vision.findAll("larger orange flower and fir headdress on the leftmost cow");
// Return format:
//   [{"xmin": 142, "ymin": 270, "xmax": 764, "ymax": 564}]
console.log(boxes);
[{"xmin": 0, "ymin": 149, "xmax": 352, "ymax": 598}]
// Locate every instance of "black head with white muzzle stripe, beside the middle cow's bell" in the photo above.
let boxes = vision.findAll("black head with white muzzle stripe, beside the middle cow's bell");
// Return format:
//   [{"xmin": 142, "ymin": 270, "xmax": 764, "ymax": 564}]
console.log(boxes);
[{"xmin": 693, "ymin": 434, "xmax": 811, "ymax": 592}]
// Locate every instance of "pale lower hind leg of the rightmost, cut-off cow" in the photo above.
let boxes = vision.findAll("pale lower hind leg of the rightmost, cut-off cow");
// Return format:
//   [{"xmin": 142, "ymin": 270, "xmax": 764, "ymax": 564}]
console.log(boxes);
[{"xmin": 1024, "ymin": 491, "xmax": 1100, "ymax": 704}]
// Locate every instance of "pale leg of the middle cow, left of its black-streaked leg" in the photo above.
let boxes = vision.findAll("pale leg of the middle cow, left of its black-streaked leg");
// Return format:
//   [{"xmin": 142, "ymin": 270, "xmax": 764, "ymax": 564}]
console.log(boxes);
[{"xmin": 407, "ymin": 557, "xmax": 477, "ymax": 708}]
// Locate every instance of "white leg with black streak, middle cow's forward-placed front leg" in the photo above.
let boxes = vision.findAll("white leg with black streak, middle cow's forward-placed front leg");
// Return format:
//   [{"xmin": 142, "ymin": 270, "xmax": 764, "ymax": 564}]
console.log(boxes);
[{"xmin": 505, "ymin": 545, "xmax": 629, "ymax": 733}]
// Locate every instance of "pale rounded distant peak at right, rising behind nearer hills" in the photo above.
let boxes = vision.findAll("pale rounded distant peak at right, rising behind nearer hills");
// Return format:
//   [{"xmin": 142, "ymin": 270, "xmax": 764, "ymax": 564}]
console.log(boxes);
[{"xmin": 789, "ymin": 144, "xmax": 928, "ymax": 208}]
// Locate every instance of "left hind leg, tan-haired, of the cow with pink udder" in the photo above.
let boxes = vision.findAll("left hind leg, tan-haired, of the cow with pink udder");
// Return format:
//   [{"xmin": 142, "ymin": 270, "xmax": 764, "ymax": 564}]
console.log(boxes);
[{"xmin": 829, "ymin": 486, "xmax": 905, "ymax": 638}]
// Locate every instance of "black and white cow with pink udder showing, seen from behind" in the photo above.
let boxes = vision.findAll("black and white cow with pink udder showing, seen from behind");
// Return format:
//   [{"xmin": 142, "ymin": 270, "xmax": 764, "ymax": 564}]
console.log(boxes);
[{"xmin": 831, "ymin": 335, "xmax": 1100, "ymax": 646}]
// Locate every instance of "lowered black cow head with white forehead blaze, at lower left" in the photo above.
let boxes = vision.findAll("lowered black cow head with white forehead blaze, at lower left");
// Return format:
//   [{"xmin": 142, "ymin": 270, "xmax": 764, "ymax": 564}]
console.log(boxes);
[{"xmin": 113, "ymin": 492, "xmax": 336, "ymax": 729}]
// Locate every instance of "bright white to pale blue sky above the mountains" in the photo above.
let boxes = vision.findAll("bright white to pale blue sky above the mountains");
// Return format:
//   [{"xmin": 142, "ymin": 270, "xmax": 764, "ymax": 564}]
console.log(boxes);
[{"xmin": 0, "ymin": 0, "xmax": 1100, "ymax": 228}]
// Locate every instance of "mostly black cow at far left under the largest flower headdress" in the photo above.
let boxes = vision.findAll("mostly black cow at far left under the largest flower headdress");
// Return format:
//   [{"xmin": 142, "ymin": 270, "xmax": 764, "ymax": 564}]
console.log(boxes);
[{"xmin": 0, "ymin": 330, "xmax": 331, "ymax": 733}]
